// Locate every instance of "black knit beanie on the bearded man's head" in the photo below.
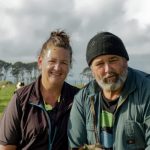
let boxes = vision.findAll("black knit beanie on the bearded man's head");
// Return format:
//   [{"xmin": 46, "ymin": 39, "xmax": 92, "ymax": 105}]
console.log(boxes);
[{"xmin": 86, "ymin": 32, "xmax": 129, "ymax": 66}]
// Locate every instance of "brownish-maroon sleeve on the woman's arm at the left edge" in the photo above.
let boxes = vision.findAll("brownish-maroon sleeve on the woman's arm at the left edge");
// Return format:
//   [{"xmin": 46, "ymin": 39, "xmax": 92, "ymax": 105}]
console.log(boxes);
[{"xmin": 0, "ymin": 94, "xmax": 20, "ymax": 145}]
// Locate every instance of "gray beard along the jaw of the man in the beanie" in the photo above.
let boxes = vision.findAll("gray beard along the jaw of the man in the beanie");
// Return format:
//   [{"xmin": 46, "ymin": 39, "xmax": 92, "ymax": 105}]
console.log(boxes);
[{"xmin": 97, "ymin": 69, "xmax": 128, "ymax": 91}]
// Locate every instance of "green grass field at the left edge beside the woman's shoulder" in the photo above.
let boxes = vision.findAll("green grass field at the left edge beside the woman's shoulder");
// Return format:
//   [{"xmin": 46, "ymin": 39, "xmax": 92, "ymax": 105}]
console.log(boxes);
[{"xmin": 0, "ymin": 84, "xmax": 15, "ymax": 117}]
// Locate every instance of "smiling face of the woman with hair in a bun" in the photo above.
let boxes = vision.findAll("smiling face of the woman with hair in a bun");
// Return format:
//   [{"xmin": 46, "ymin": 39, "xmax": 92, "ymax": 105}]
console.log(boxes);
[{"xmin": 38, "ymin": 47, "xmax": 71, "ymax": 85}]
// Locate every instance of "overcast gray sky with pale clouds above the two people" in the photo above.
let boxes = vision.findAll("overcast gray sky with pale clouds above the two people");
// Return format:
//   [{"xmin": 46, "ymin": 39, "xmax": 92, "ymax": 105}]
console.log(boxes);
[{"xmin": 0, "ymin": 0, "xmax": 150, "ymax": 79}]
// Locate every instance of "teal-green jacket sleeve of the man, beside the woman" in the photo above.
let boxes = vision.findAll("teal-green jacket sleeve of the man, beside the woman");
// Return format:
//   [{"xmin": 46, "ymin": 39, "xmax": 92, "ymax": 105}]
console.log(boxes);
[{"xmin": 68, "ymin": 91, "xmax": 87, "ymax": 148}]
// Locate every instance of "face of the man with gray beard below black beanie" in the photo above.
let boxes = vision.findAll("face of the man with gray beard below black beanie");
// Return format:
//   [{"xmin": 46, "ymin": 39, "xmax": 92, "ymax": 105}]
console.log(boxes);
[{"xmin": 91, "ymin": 55, "xmax": 128, "ymax": 91}]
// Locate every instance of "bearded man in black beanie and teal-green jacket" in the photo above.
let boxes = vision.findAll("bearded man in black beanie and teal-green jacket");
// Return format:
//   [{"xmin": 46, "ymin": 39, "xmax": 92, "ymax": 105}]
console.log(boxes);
[{"xmin": 68, "ymin": 32, "xmax": 150, "ymax": 150}]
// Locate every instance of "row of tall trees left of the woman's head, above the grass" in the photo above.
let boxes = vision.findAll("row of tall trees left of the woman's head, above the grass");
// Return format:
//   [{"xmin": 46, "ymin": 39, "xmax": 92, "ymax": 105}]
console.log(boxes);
[{"xmin": 0, "ymin": 60, "xmax": 39, "ymax": 83}]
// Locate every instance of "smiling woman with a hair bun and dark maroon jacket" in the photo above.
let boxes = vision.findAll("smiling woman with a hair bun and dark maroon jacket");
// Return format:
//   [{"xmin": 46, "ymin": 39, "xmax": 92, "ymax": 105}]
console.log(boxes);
[{"xmin": 0, "ymin": 31, "xmax": 79, "ymax": 150}]
